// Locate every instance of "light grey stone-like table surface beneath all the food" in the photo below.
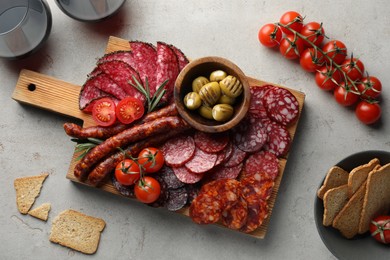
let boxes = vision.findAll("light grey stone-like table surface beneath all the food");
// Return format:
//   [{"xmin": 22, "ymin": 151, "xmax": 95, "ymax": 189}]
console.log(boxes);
[{"xmin": 0, "ymin": 0, "xmax": 390, "ymax": 259}]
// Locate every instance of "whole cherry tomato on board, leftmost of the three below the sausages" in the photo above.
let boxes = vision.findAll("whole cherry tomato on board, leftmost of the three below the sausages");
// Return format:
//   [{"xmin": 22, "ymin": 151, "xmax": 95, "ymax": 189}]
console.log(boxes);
[{"xmin": 115, "ymin": 159, "xmax": 140, "ymax": 185}]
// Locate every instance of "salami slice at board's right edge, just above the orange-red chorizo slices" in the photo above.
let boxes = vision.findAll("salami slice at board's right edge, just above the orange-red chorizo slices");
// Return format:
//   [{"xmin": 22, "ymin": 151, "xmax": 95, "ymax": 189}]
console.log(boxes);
[{"xmin": 244, "ymin": 151, "xmax": 279, "ymax": 180}]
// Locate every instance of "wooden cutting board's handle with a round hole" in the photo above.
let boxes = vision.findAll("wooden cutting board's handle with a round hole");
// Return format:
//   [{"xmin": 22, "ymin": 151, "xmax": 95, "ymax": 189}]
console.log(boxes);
[{"xmin": 12, "ymin": 69, "xmax": 93, "ymax": 126}]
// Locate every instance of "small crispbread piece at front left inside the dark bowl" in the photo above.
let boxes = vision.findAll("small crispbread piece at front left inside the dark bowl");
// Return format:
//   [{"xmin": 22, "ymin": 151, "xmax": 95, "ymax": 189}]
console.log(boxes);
[{"xmin": 322, "ymin": 184, "xmax": 348, "ymax": 226}]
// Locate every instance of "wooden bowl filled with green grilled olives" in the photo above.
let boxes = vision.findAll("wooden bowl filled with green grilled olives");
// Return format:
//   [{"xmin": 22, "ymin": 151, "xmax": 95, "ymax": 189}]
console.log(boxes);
[{"xmin": 174, "ymin": 57, "xmax": 250, "ymax": 133}]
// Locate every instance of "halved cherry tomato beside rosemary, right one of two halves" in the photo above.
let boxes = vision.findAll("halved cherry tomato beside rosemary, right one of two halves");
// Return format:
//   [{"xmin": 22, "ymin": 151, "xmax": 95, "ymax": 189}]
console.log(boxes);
[{"xmin": 116, "ymin": 97, "xmax": 145, "ymax": 124}]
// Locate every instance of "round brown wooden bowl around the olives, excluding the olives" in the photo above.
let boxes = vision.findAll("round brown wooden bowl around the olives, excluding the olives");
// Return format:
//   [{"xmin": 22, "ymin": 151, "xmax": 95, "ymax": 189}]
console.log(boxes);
[{"xmin": 174, "ymin": 57, "xmax": 251, "ymax": 133}]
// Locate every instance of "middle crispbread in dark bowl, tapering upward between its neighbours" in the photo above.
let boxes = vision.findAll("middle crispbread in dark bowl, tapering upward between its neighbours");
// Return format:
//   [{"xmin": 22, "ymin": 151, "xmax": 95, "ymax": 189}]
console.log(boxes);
[{"xmin": 332, "ymin": 181, "xmax": 367, "ymax": 239}]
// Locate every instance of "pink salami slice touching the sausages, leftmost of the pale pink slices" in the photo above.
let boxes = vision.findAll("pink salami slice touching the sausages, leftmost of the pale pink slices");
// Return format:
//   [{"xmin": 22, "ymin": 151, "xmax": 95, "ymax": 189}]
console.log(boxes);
[{"xmin": 161, "ymin": 135, "xmax": 195, "ymax": 167}]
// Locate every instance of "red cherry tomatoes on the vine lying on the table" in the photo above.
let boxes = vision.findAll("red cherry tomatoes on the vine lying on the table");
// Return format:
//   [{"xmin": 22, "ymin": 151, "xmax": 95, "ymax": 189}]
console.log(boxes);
[{"xmin": 258, "ymin": 11, "xmax": 382, "ymax": 124}]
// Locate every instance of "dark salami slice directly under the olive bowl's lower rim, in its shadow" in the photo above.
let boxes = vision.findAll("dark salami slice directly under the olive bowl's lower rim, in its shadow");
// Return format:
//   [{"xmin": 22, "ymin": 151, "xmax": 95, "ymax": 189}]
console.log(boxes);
[{"xmin": 194, "ymin": 131, "xmax": 229, "ymax": 153}]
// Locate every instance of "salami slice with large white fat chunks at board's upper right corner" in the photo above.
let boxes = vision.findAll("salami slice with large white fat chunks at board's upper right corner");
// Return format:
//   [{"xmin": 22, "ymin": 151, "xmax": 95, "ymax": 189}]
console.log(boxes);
[{"xmin": 263, "ymin": 88, "xmax": 299, "ymax": 125}]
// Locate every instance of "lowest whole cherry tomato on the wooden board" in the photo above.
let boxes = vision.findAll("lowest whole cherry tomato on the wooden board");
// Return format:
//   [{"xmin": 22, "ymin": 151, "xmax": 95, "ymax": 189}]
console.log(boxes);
[{"xmin": 134, "ymin": 176, "xmax": 161, "ymax": 203}]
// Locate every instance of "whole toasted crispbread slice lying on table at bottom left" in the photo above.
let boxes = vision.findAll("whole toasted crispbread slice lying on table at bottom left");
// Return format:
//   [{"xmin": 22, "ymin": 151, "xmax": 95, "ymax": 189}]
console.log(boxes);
[{"xmin": 49, "ymin": 209, "xmax": 106, "ymax": 254}]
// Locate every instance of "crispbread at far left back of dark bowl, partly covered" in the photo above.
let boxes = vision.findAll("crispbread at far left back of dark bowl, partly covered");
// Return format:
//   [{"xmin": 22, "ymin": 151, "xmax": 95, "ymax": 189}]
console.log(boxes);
[{"xmin": 317, "ymin": 166, "xmax": 349, "ymax": 199}]
